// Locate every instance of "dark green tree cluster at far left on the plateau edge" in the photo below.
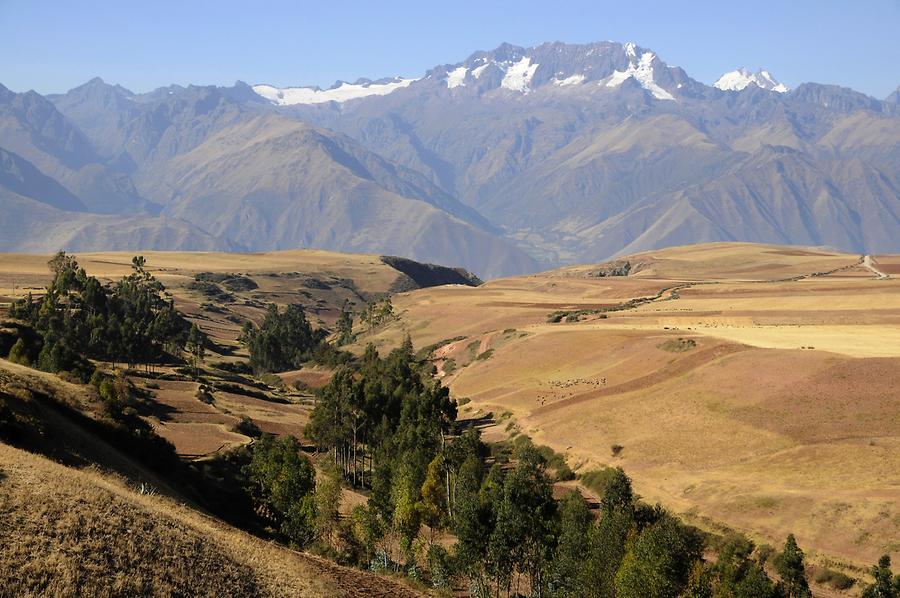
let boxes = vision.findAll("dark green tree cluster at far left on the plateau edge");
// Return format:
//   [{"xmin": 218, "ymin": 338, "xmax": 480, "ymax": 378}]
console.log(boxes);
[{"xmin": 10, "ymin": 252, "xmax": 190, "ymax": 379}]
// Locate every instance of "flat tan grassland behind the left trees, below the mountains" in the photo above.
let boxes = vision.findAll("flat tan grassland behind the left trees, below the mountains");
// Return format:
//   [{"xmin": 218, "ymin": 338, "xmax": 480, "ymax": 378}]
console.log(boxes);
[{"xmin": 0, "ymin": 249, "xmax": 464, "ymax": 345}]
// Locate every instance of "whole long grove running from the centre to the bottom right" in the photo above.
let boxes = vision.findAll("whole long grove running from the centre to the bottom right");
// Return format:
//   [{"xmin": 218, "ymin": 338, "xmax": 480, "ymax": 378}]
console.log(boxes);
[{"xmin": 304, "ymin": 340, "xmax": 868, "ymax": 598}]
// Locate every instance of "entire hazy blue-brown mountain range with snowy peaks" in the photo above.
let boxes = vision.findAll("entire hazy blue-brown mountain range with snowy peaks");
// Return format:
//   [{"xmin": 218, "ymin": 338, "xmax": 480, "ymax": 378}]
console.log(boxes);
[{"xmin": 0, "ymin": 42, "xmax": 900, "ymax": 277}]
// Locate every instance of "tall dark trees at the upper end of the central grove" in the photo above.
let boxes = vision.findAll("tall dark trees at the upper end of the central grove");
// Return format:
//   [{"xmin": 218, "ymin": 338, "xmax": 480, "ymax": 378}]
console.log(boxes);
[{"xmin": 306, "ymin": 340, "xmax": 456, "ymax": 553}]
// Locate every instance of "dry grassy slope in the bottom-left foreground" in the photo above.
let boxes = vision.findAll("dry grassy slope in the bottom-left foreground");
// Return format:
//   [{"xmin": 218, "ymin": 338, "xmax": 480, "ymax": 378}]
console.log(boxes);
[{"xmin": 0, "ymin": 360, "xmax": 424, "ymax": 597}]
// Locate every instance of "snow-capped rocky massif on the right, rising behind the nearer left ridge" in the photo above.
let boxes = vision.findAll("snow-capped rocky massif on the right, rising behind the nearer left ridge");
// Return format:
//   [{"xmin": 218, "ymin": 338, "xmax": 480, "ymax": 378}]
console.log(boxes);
[{"xmin": 279, "ymin": 42, "xmax": 900, "ymax": 264}]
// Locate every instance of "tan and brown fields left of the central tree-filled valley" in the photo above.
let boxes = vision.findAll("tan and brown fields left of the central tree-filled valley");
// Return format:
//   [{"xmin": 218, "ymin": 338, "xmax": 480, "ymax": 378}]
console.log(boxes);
[{"xmin": 0, "ymin": 250, "xmax": 458, "ymax": 459}]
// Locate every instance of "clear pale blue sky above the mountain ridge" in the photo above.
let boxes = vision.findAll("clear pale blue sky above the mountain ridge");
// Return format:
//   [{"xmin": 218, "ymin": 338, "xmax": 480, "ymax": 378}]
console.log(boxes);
[{"xmin": 0, "ymin": 0, "xmax": 900, "ymax": 98}]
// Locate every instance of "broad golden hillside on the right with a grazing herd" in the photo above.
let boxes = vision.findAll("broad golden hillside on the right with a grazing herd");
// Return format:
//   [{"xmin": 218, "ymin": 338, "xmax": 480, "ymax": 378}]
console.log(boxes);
[{"xmin": 359, "ymin": 243, "xmax": 900, "ymax": 568}]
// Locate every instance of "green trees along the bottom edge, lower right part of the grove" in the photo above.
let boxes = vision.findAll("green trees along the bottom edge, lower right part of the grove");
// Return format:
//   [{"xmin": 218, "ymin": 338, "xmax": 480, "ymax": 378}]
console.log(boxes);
[{"xmin": 442, "ymin": 445, "xmax": 810, "ymax": 598}]
